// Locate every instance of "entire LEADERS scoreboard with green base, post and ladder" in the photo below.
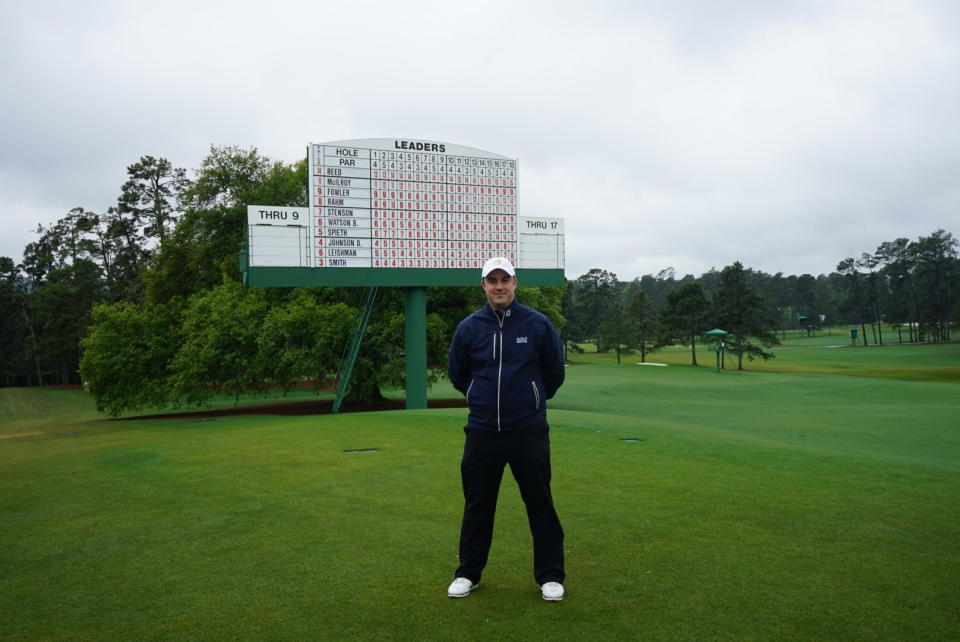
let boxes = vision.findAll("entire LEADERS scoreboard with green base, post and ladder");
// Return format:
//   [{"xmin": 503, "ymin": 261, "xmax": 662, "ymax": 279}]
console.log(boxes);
[{"xmin": 239, "ymin": 138, "xmax": 566, "ymax": 409}]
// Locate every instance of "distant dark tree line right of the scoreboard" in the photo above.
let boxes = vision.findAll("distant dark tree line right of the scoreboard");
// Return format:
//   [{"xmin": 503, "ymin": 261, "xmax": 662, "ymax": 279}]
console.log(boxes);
[{"xmin": 564, "ymin": 230, "xmax": 960, "ymax": 360}]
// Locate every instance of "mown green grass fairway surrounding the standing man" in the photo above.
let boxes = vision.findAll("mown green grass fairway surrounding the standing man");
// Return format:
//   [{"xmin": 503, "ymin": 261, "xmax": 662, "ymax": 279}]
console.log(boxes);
[{"xmin": 0, "ymin": 344, "xmax": 960, "ymax": 640}]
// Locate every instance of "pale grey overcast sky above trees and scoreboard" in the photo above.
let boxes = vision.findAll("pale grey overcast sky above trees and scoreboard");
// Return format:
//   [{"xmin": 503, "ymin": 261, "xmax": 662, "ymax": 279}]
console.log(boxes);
[{"xmin": 0, "ymin": 0, "xmax": 960, "ymax": 280}]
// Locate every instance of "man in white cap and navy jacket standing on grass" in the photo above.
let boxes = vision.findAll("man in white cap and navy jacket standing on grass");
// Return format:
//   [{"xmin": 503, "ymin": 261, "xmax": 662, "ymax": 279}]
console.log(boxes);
[{"xmin": 447, "ymin": 257, "xmax": 564, "ymax": 601}]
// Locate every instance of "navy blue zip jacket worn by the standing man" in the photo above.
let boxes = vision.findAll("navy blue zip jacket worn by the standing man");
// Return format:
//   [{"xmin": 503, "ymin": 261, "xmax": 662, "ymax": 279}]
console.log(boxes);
[{"xmin": 447, "ymin": 299, "xmax": 564, "ymax": 430}]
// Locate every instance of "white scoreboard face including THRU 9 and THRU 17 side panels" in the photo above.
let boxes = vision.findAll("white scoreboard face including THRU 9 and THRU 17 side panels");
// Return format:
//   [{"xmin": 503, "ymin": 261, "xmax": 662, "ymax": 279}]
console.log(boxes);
[{"xmin": 246, "ymin": 138, "xmax": 564, "ymax": 283}]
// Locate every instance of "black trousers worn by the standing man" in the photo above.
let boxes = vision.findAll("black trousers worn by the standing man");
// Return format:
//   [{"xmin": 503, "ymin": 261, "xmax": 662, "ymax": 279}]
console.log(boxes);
[{"xmin": 455, "ymin": 424, "xmax": 565, "ymax": 584}]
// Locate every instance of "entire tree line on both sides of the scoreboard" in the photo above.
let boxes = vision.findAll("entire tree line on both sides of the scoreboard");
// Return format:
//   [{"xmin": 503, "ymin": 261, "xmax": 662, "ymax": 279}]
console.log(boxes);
[{"xmin": 0, "ymin": 146, "xmax": 958, "ymax": 414}]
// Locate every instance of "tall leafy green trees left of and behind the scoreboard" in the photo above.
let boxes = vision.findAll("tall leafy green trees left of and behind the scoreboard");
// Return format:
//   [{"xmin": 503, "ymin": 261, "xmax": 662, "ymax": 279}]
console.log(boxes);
[{"xmin": 0, "ymin": 147, "xmax": 563, "ymax": 414}]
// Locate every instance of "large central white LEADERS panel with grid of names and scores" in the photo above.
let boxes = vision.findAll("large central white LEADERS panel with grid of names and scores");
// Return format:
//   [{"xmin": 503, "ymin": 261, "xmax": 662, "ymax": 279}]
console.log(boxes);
[{"xmin": 308, "ymin": 138, "xmax": 516, "ymax": 269}]
